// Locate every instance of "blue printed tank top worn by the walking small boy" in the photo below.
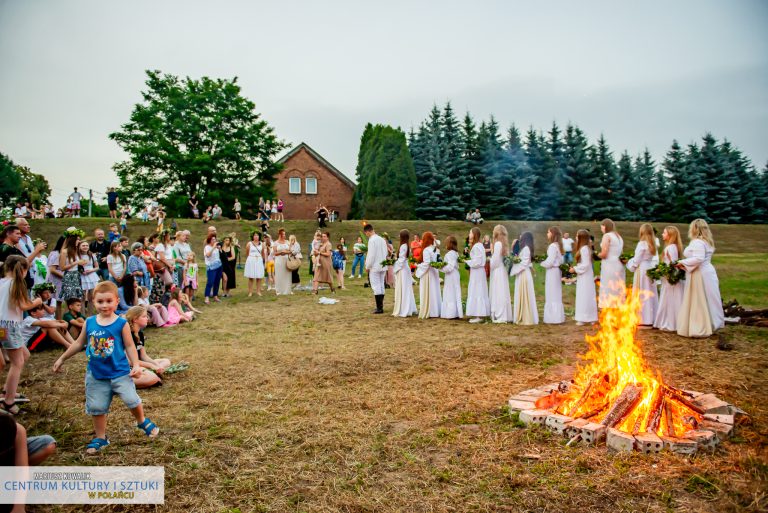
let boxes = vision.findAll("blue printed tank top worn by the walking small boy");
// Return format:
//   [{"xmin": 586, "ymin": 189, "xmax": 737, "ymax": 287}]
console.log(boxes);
[{"xmin": 85, "ymin": 315, "xmax": 131, "ymax": 379}]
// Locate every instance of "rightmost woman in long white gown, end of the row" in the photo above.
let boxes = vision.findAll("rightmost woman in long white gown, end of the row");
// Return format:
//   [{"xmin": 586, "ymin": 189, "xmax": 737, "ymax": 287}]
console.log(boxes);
[{"xmin": 677, "ymin": 219, "xmax": 725, "ymax": 337}]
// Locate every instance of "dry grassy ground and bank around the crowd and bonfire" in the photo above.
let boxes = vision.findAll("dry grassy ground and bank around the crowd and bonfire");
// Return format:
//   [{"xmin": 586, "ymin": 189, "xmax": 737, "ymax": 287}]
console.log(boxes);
[{"xmin": 19, "ymin": 220, "xmax": 768, "ymax": 513}]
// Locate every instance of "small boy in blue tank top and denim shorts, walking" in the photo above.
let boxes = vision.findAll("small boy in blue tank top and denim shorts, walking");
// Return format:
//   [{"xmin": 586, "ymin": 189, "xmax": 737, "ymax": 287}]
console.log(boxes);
[{"xmin": 53, "ymin": 281, "xmax": 160, "ymax": 454}]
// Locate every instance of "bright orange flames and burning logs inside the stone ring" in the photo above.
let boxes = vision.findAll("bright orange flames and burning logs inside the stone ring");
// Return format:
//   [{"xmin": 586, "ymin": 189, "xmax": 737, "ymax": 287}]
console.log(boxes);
[{"xmin": 557, "ymin": 284, "xmax": 701, "ymax": 436}]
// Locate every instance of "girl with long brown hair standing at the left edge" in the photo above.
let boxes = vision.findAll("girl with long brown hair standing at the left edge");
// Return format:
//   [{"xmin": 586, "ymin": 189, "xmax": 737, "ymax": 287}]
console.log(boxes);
[{"xmin": 0, "ymin": 255, "xmax": 42, "ymax": 415}]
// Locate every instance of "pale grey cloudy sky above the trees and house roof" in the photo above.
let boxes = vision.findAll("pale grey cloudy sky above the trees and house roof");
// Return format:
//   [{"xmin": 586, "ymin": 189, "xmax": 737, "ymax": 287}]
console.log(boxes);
[{"xmin": 0, "ymin": 0, "xmax": 768, "ymax": 206}]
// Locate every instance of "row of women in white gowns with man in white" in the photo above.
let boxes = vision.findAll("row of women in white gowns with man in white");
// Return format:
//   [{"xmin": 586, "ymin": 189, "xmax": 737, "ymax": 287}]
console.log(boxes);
[{"xmin": 378, "ymin": 219, "xmax": 724, "ymax": 337}]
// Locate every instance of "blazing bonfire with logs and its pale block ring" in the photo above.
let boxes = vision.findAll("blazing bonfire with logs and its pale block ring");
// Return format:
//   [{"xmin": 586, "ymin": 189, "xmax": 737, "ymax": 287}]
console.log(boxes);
[{"xmin": 510, "ymin": 289, "xmax": 743, "ymax": 453}]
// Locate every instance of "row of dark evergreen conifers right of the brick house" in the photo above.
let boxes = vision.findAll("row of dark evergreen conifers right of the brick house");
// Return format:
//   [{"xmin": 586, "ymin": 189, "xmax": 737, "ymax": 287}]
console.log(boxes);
[{"xmin": 356, "ymin": 103, "xmax": 768, "ymax": 223}]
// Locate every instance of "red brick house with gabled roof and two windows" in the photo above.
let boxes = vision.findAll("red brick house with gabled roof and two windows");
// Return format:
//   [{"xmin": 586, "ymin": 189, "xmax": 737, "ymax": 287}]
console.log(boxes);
[{"xmin": 275, "ymin": 143, "xmax": 355, "ymax": 219}]
